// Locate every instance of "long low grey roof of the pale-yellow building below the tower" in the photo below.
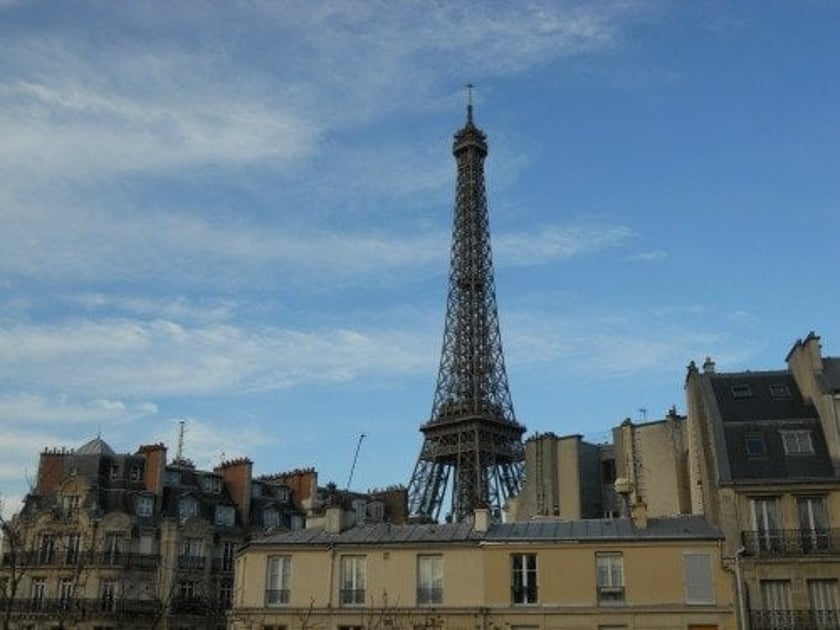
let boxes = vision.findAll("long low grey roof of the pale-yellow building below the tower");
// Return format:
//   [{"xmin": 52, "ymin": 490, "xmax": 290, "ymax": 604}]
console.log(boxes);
[{"xmin": 251, "ymin": 516, "xmax": 723, "ymax": 546}]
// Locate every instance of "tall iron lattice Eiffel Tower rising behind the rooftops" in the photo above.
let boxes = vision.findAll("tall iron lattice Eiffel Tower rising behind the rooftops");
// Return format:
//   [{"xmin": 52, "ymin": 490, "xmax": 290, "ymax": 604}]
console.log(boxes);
[{"xmin": 408, "ymin": 102, "xmax": 525, "ymax": 521}]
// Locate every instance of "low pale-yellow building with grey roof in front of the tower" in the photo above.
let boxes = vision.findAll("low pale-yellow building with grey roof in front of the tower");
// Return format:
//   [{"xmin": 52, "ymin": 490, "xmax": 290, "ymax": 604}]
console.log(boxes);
[{"xmin": 229, "ymin": 510, "xmax": 735, "ymax": 630}]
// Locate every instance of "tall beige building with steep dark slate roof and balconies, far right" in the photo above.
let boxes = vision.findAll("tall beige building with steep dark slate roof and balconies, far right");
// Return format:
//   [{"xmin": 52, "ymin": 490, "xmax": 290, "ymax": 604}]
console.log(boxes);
[{"xmin": 685, "ymin": 333, "xmax": 840, "ymax": 630}]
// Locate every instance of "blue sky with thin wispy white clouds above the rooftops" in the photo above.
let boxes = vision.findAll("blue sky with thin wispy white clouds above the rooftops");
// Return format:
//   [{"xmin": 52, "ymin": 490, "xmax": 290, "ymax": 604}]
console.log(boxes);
[{"xmin": 0, "ymin": 0, "xmax": 840, "ymax": 511}]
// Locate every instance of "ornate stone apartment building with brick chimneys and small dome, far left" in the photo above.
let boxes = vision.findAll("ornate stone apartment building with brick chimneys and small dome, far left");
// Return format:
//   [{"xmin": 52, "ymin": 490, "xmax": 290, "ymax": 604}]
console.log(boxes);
[{"xmin": 0, "ymin": 437, "xmax": 306, "ymax": 630}]
